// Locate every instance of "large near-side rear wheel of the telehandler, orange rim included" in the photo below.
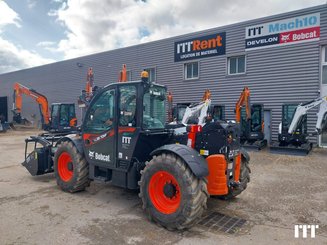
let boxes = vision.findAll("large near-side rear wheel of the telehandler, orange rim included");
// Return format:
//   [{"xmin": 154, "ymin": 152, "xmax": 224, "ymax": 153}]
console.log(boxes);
[{"xmin": 139, "ymin": 153, "xmax": 209, "ymax": 230}]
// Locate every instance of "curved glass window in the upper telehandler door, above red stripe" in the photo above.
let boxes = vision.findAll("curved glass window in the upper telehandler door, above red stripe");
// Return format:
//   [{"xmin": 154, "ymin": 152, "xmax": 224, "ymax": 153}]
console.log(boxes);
[{"xmin": 84, "ymin": 89, "xmax": 115, "ymax": 133}]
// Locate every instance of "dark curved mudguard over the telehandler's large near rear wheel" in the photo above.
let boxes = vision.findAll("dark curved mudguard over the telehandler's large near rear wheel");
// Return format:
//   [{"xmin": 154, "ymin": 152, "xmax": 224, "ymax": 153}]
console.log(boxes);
[{"xmin": 150, "ymin": 144, "xmax": 209, "ymax": 178}]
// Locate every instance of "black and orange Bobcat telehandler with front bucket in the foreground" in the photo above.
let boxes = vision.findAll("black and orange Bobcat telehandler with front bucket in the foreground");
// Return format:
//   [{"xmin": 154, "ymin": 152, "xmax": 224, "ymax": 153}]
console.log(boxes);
[{"xmin": 23, "ymin": 74, "xmax": 250, "ymax": 230}]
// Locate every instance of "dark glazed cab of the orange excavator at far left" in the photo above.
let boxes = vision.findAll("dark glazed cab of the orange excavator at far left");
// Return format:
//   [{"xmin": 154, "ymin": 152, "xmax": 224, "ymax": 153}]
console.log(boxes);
[{"xmin": 49, "ymin": 103, "xmax": 77, "ymax": 132}]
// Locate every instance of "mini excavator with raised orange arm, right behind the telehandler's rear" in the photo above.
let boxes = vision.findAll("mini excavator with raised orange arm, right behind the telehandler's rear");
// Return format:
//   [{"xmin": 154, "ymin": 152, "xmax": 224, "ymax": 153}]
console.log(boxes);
[{"xmin": 235, "ymin": 87, "xmax": 267, "ymax": 150}]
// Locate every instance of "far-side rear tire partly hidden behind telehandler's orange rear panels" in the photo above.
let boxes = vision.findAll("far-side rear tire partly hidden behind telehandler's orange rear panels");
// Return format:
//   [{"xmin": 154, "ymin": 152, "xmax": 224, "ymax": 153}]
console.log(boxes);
[{"xmin": 218, "ymin": 159, "xmax": 251, "ymax": 200}]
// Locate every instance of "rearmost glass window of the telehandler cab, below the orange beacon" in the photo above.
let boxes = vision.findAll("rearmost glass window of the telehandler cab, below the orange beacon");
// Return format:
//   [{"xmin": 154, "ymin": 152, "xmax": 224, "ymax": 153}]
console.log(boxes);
[{"xmin": 142, "ymin": 86, "xmax": 166, "ymax": 129}]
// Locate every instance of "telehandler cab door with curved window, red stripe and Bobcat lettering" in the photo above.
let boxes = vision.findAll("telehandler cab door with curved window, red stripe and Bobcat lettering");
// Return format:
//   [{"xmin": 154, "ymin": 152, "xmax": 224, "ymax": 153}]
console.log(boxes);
[{"xmin": 82, "ymin": 87, "xmax": 117, "ymax": 168}]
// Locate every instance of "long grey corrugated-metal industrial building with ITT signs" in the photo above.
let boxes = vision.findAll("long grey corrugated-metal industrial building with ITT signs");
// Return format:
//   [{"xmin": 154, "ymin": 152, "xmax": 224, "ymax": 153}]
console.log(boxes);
[{"xmin": 0, "ymin": 5, "xmax": 327, "ymax": 146}]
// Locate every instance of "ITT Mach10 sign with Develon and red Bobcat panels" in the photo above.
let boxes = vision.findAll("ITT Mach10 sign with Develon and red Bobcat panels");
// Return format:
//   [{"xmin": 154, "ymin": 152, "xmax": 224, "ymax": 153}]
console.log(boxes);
[{"xmin": 245, "ymin": 13, "xmax": 320, "ymax": 49}]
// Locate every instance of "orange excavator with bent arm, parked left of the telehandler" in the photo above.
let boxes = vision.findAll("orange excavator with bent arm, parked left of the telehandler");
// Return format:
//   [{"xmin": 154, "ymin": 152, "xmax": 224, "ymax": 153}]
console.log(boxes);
[{"xmin": 12, "ymin": 83, "xmax": 77, "ymax": 132}]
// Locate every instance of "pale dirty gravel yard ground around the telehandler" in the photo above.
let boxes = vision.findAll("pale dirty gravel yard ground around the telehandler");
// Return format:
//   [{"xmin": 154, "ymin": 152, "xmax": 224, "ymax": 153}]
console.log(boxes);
[{"xmin": 0, "ymin": 131, "xmax": 327, "ymax": 244}]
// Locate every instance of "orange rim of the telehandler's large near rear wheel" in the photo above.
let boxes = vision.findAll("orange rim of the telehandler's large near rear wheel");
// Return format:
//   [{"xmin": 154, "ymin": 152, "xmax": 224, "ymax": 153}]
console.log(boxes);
[{"xmin": 148, "ymin": 171, "xmax": 181, "ymax": 214}]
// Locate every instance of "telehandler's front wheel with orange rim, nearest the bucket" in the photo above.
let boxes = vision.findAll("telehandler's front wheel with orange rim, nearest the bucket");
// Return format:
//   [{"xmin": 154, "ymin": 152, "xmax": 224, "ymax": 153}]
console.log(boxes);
[{"xmin": 54, "ymin": 141, "xmax": 90, "ymax": 192}]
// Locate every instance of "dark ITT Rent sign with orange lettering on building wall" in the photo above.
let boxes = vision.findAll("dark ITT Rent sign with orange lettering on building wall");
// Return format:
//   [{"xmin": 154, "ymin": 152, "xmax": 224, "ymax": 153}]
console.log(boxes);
[{"xmin": 175, "ymin": 32, "xmax": 226, "ymax": 62}]
